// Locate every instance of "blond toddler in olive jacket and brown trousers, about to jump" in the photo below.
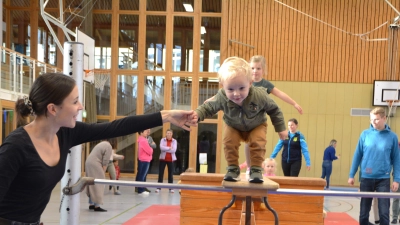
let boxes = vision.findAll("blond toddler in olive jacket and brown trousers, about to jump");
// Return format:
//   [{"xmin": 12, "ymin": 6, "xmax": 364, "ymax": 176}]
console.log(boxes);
[{"xmin": 195, "ymin": 57, "xmax": 287, "ymax": 183}]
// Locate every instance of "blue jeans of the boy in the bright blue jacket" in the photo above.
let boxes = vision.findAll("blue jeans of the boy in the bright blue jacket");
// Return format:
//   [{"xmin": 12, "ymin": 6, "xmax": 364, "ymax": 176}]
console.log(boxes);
[{"xmin": 359, "ymin": 178, "xmax": 390, "ymax": 225}]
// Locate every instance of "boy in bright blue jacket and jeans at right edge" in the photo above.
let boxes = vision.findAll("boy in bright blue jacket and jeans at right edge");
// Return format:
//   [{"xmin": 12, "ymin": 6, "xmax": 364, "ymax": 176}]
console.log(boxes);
[{"xmin": 347, "ymin": 107, "xmax": 400, "ymax": 225}]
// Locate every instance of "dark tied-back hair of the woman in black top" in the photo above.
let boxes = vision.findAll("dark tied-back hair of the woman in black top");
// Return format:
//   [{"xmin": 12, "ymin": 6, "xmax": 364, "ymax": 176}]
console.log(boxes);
[{"xmin": 15, "ymin": 73, "xmax": 76, "ymax": 125}]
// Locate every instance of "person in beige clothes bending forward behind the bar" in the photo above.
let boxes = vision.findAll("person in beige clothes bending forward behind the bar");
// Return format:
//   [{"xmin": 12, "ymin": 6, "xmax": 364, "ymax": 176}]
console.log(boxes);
[{"xmin": 85, "ymin": 141, "xmax": 112, "ymax": 212}]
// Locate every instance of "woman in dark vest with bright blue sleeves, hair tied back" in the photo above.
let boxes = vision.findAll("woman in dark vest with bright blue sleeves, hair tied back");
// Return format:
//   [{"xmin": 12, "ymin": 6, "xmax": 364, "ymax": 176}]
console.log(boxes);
[{"xmin": 270, "ymin": 118, "xmax": 311, "ymax": 177}]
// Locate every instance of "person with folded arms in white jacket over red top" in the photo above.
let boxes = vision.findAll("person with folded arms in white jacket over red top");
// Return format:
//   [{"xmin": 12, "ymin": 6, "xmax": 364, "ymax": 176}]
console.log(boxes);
[{"xmin": 156, "ymin": 129, "xmax": 178, "ymax": 193}]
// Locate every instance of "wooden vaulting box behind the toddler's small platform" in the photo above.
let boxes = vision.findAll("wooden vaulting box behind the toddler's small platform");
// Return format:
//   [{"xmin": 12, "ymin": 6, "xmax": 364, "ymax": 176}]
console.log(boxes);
[{"xmin": 180, "ymin": 173, "xmax": 325, "ymax": 225}]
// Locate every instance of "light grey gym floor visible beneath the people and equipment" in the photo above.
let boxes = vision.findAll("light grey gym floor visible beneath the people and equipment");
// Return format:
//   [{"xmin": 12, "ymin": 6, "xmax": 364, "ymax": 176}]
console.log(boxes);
[{"xmin": 41, "ymin": 179, "xmax": 384, "ymax": 225}]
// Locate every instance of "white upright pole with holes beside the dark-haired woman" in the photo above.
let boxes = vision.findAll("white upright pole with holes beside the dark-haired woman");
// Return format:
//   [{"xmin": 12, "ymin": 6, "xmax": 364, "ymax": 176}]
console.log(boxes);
[{"xmin": 60, "ymin": 42, "xmax": 83, "ymax": 225}]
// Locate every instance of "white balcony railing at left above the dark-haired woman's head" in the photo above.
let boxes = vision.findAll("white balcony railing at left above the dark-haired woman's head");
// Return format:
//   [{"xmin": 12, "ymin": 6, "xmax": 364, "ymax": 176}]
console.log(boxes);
[{"xmin": 0, "ymin": 47, "xmax": 62, "ymax": 101}]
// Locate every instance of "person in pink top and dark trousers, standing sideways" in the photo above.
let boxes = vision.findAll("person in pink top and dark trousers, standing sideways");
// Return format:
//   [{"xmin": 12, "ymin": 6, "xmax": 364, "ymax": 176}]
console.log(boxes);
[{"xmin": 136, "ymin": 129, "xmax": 153, "ymax": 195}]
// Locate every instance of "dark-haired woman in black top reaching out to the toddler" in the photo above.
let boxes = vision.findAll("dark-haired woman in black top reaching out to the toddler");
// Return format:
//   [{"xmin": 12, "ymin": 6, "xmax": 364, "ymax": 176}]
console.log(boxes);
[{"xmin": 0, "ymin": 74, "xmax": 197, "ymax": 224}]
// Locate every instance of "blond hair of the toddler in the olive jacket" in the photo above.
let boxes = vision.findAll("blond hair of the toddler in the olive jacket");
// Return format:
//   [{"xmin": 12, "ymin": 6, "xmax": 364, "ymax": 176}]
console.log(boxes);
[{"xmin": 218, "ymin": 57, "xmax": 251, "ymax": 84}]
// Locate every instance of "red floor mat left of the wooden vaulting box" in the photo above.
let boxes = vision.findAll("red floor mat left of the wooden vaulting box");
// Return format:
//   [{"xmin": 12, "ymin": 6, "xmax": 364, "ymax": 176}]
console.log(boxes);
[{"xmin": 123, "ymin": 205, "xmax": 180, "ymax": 225}]
